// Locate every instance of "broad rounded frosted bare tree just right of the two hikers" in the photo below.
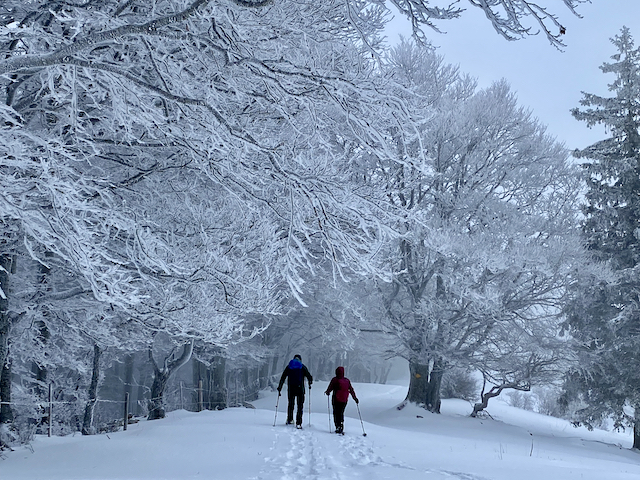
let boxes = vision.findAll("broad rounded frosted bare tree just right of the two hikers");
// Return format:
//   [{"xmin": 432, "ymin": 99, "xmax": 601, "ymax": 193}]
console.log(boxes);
[{"xmin": 372, "ymin": 44, "xmax": 580, "ymax": 412}]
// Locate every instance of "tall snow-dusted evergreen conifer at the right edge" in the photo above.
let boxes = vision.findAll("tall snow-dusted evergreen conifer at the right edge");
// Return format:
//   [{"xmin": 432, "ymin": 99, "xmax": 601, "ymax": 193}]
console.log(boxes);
[{"xmin": 568, "ymin": 27, "xmax": 640, "ymax": 448}]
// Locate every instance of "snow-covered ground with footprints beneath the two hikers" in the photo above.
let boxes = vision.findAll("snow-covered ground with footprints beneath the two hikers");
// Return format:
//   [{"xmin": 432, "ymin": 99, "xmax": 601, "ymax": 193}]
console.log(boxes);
[{"xmin": 0, "ymin": 382, "xmax": 640, "ymax": 480}]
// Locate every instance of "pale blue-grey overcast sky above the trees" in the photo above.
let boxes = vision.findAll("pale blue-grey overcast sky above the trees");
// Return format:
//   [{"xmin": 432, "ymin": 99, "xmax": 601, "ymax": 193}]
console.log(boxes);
[{"xmin": 388, "ymin": 0, "xmax": 640, "ymax": 153}]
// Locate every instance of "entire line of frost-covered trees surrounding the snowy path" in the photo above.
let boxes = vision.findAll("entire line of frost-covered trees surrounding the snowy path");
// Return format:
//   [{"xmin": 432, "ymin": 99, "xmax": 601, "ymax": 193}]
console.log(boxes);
[{"xmin": 0, "ymin": 0, "xmax": 640, "ymax": 448}]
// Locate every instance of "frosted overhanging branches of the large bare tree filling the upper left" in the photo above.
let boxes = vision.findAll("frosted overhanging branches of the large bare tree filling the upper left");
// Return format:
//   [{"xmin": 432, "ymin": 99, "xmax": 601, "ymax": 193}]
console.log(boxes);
[{"xmin": 0, "ymin": 0, "xmax": 592, "ymax": 438}]
